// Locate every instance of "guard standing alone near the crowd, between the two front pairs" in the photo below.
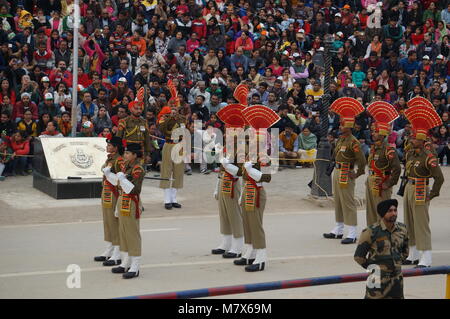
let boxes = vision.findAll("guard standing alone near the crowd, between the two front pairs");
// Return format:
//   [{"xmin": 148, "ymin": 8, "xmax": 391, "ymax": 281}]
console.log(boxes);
[{"xmin": 158, "ymin": 106, "xmax": 186, "ymax": 209}]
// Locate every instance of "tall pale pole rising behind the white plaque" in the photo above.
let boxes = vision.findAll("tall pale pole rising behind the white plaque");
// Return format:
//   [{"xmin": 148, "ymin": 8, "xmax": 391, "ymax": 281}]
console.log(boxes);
[{"xmin": 72, "ymin": 0, "xmax": 80, "ymax": 137}]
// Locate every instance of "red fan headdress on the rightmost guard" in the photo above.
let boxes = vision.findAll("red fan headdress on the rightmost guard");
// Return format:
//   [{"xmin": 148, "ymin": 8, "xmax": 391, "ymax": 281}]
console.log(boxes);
[{"xmin": 405, "ymin": 105, "xmax": 442, "ymax": 140}]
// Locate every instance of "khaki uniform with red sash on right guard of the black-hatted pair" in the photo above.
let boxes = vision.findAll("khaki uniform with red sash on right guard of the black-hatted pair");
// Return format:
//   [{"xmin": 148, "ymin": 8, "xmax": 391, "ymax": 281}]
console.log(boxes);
[{"xmin": 117, "ymin": 160, "xmax": 145, "ymax": 257}]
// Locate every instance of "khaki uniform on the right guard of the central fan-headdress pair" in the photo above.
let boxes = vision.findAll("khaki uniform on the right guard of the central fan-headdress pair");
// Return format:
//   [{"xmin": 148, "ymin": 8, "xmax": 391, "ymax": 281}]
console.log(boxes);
[{"xmin": 241, "ymin": 163, "xmax": 272, "ymax": 249}]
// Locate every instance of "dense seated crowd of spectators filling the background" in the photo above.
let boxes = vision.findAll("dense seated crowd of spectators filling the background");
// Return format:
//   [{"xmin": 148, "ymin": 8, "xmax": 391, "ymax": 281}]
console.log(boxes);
[{"xmin": 0, "ymin": 0, "xmax": 450, "ymax": 180}]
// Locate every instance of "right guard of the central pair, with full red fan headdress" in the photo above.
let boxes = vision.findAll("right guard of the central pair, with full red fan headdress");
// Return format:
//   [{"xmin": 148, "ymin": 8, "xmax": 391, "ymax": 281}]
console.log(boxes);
[{"xmin": 234, "ymin": 105, "xmax": 280, "ymax": 272}]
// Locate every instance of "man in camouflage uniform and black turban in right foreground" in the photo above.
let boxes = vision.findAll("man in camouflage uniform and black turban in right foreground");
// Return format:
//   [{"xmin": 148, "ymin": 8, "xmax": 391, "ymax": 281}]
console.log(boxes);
[{"xmin": 354, "ymin": 199, "xmax": 408, "ymax": 299}]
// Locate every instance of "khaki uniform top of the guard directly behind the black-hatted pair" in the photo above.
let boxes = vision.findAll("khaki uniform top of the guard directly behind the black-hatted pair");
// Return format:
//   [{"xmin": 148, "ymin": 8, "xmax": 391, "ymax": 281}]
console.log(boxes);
[{"xmin": 116, "ymin": 115, "xmax": 151, "ymax": 156}]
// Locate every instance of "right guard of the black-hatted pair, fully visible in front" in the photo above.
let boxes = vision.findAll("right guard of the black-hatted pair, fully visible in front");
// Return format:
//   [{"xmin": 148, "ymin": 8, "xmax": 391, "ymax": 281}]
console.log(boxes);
[{"xmin": 112, "ymin": 143, "xmax": 145, "ymax": 279}]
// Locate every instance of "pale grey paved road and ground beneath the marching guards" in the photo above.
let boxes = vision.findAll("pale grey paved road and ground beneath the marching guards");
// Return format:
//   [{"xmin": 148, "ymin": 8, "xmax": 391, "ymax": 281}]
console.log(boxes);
[{"xmin": 0, "ymin": 167, "xmax": 450, "ymax": 298}]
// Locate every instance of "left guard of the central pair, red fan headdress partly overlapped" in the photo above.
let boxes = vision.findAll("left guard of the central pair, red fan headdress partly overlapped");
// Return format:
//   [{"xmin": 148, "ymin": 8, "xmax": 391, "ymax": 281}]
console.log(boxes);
[{"xmin": 211, "ymin": 104, "xmax": 245, "ymax": 258}]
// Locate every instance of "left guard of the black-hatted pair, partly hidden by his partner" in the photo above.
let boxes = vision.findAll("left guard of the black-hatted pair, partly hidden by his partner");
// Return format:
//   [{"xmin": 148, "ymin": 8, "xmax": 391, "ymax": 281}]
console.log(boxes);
[{"xmin": 94, "ymin": 135, "xmax": 124, "ymax": 266}]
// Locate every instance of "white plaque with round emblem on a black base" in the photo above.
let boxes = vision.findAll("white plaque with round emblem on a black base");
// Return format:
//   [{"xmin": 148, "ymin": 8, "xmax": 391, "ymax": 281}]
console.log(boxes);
[{"xmin": 40, "ymin": 137, "xmax": 107, "ymax": 179}]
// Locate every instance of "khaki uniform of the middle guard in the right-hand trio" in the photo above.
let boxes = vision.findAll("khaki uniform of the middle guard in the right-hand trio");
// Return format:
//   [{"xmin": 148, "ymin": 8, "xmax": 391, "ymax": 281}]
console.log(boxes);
[{"xmin": 366, "ymin": 141, "xmax": 401, "ymax": 226}]
